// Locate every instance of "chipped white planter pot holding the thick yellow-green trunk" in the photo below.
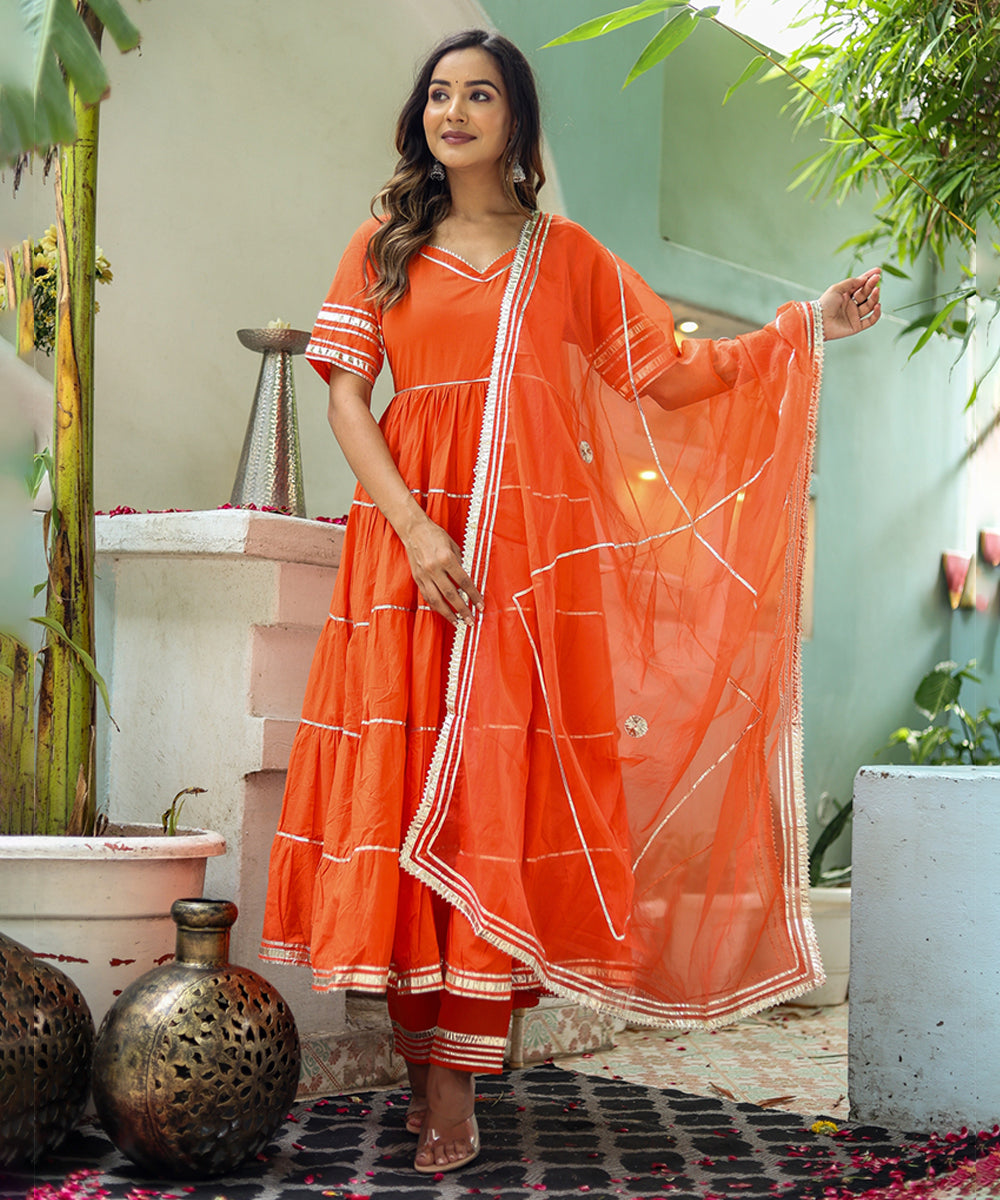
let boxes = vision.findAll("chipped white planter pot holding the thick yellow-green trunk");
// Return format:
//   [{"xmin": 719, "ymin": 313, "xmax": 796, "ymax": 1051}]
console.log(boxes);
[{"xmin": 0, "ymin": 826, "xmax": 226, "ymax": 1025}]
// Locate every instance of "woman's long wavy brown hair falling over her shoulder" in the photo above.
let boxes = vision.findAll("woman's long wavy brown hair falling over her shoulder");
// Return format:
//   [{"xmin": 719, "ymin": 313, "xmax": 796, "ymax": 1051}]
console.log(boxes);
[{"xmin": 365, "ymin": 29, "xmax": 545, "ymax": 310}]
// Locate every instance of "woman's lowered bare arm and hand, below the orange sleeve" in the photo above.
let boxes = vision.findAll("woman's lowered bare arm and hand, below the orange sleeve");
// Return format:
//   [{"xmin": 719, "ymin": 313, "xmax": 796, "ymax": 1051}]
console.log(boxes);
[{"xmin": 328, "ymin": 367, "xmax": 483, "ymax": 624}]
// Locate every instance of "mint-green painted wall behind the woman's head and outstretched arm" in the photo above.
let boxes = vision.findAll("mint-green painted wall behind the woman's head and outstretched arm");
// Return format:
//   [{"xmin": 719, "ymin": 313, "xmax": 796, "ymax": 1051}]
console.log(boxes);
[{"xmin": 486, "ymin": 0, "xmax": 1000, "ymax": 854}]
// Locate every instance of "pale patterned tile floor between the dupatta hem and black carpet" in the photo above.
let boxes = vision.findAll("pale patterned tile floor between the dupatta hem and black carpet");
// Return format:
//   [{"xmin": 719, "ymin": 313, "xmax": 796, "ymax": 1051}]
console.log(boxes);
[{"xmin": 558, "ymin": 1004, "xmax": 848, "ymax": 1120}]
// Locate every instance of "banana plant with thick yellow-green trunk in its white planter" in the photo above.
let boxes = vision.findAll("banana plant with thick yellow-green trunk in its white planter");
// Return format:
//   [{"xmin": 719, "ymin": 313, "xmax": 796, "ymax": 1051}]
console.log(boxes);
[{"xmin": 0, "ymin": 0, "xmax": 224, "ymax": 1021}]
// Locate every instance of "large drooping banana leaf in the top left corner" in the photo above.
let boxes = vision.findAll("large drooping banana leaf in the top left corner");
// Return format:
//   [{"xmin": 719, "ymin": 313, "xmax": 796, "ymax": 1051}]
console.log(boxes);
[{"xmin": 0, "ymin": 0, "xmax": 139, "ymax": 167}]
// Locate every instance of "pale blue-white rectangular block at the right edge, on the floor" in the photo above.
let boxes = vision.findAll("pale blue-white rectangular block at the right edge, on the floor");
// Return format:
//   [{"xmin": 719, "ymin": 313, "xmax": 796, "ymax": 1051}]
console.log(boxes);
[{"xmin": 849, "ymin": 767, "xmax": 1000, "ymax": 1133}]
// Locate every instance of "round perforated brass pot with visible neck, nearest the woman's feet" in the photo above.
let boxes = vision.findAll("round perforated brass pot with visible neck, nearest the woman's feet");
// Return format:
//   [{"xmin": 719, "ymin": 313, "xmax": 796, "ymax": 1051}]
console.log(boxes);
[{"xmin": 94, "ymin": 900, "xmax": 299, "ymax": 1177}]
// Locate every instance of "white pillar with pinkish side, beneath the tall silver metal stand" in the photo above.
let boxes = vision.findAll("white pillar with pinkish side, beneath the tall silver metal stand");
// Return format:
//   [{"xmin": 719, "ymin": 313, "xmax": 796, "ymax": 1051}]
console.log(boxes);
[{"xmin": 97, "ymin": 509, "xmax": 345, "ymax": 1034}]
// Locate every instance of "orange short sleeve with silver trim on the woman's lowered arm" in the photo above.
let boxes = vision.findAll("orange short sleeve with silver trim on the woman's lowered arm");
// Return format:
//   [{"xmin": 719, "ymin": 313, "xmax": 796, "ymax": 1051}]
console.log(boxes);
[{"xmin": 306, "ymin": 218, "xmax": 385, "ymax": 384}]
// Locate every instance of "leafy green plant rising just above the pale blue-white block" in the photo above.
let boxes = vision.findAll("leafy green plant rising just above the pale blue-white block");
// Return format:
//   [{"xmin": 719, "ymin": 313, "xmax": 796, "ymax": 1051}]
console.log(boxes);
[{"xmin": 882, "ymin": 659, "xmax": 1000, "ymax": 767}]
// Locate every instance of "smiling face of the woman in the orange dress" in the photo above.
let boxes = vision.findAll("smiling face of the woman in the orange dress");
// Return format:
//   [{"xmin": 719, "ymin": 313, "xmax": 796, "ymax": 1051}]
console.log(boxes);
[{"xmin": 424, "ymin": 46, "xmax": 513, "ymax": 172}]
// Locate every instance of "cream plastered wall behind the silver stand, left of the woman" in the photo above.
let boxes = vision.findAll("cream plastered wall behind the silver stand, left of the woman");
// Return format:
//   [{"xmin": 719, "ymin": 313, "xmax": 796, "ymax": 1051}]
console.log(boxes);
[{"xmin": 0, "ymin": 0, "xmax": 557, "ymax": 516}]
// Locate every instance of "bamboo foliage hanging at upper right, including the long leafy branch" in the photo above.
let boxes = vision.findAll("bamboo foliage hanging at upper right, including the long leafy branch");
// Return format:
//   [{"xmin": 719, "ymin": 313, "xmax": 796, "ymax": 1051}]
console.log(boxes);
[{"xmin": 549, "ymin": 0, "xmax": 1000, "ymax": 393}]
